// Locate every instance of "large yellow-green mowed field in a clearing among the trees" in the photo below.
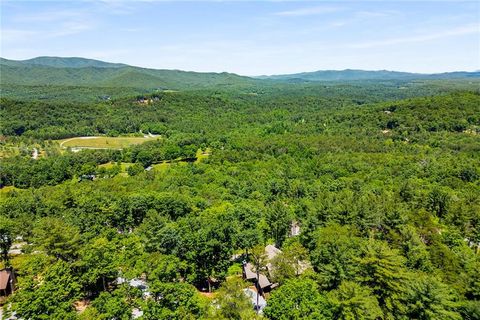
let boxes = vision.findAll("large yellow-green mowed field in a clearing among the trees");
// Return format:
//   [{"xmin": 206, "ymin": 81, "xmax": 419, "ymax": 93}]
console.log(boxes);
[{"xmin": 57, "ymin": 136, "xmax": 160, "ymax": 149}]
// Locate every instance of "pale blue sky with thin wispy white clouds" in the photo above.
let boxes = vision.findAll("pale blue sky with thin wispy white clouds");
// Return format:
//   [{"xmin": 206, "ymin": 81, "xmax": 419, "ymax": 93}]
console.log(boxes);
[{"xmin": 0, "ymin": 0, "xmax": 480, "ymax": 75}]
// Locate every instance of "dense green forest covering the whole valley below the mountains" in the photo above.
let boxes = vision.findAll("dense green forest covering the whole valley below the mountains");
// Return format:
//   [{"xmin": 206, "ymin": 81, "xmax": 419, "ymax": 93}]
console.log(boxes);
[{"xmin": 0, "ymin": 67, "xmax": 480, "ymax": 320}]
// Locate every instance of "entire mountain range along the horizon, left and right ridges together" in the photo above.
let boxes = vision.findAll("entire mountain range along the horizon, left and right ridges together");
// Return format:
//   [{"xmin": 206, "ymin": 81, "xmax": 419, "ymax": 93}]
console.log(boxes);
[{"xmin": 0, "ymin": 57, "xmax": 480, "ymax": 89}]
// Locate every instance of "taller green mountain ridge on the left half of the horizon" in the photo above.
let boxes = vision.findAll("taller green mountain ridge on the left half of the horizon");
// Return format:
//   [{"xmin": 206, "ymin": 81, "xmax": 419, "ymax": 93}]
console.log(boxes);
[{"xmin": 0, "ymin": 57, "xmax": 255, "ymax": 89}]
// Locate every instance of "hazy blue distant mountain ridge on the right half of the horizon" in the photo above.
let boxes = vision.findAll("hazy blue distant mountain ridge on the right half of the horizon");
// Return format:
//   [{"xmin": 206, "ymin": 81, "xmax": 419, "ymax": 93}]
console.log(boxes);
[{"xmin": 257, "ymin": 69, "xmax": 480, "ymax": 81}]
